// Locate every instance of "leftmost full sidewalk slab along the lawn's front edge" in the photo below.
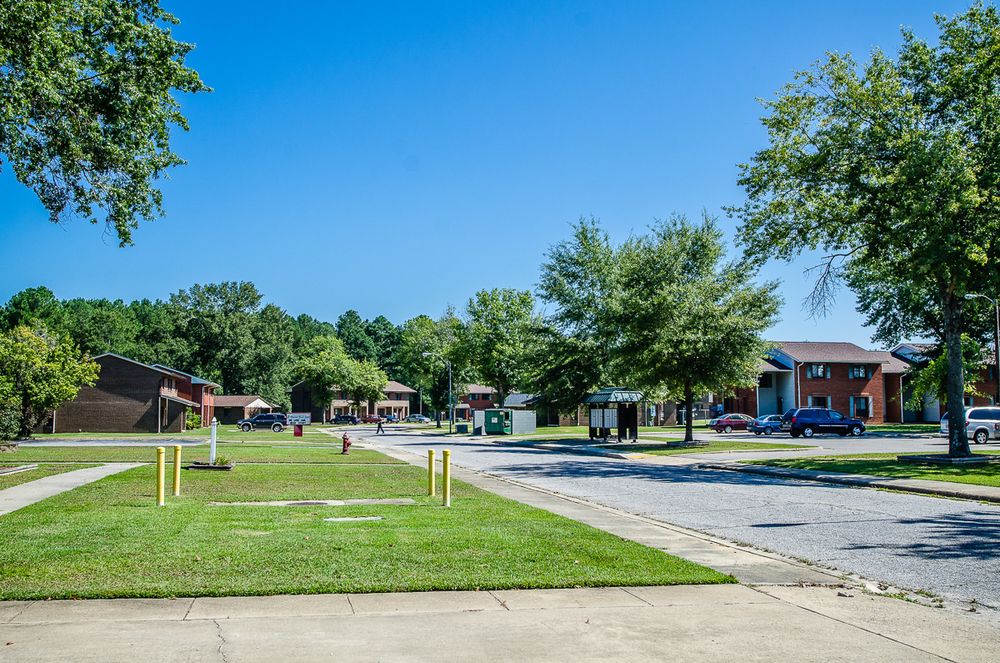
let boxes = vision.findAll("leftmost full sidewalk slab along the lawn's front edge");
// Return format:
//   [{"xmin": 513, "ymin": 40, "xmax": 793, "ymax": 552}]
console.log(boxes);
[{"xmin": 9, "ymin": 599, "xmax": 194, "ymax": 624}]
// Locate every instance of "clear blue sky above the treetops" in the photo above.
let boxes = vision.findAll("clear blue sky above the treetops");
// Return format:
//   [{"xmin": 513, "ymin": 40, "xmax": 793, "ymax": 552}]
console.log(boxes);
[{"xmin": 0, "ymin": 0, "xmax": 968, "ymax": 347}]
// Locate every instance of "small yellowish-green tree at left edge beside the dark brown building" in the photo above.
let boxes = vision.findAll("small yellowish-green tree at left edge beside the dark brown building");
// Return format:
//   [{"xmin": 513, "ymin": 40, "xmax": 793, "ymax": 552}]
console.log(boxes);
[{"xmin": 0, "ymin": 325, "xmax": 100, "ymax": 438}]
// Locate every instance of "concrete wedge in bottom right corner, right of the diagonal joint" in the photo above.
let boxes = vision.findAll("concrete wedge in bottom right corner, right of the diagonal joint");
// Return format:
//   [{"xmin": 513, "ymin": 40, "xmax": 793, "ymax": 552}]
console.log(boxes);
[{"xmin": 761, "ymin": 587, "xmax": 1000, "ymax": 661}]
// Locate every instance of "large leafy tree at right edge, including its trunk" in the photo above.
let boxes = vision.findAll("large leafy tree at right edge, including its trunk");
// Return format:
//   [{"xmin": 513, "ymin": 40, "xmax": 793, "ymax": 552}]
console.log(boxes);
[{"xmin": 730, "ymin": 2, "xmax": 1000, "ymax": 456}]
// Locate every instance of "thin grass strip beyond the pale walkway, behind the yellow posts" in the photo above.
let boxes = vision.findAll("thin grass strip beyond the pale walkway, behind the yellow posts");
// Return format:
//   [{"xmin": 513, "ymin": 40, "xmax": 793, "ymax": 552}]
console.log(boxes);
[{"xmin": 4, "ymin": 442, "xmax": 402, "ymax": 465}]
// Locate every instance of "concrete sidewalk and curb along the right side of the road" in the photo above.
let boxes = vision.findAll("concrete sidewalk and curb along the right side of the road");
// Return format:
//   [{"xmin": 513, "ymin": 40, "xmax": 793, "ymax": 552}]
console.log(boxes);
[{"xmin": 695, "ymin": 462, "xmax": 1000, "ymax": 504}]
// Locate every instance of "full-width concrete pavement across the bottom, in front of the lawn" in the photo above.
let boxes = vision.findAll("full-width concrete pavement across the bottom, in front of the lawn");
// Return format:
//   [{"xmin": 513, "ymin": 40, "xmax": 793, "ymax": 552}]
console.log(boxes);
[{"xmin": 0, "ymin": 585, "xmax": 1000, "ymax": 663}]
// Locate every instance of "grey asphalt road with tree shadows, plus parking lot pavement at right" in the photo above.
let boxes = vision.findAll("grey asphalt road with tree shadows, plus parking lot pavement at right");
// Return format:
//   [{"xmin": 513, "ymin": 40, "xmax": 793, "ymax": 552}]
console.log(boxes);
[{"xmin": 362, "ymin": 429, "xmax": 1000, "ymax": 606}]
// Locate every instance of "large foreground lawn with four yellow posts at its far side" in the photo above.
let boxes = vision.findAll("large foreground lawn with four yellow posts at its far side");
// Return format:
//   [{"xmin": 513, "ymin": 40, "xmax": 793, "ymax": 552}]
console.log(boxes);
[{"xmin": 0, "ymin": 465, "xmax": 734, "ymax": 600}]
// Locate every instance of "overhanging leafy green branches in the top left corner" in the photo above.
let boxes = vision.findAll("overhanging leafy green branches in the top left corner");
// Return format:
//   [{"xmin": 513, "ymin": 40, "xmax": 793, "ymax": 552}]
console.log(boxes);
[{"xmin": 0, "ymin": 0, "xmax": 209, "ymax": 246}]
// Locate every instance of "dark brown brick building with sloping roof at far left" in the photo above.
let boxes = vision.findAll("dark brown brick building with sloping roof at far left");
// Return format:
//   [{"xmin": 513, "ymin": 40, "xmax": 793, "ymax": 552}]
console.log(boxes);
[{"xmin": 41, "ymin": 353, "xmax": 198, "ymax": 433}]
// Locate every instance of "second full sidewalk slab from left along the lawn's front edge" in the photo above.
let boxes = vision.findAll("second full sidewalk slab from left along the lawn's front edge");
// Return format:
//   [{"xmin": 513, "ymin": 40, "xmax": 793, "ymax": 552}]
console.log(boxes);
[{"xmin": 185, "ymin": 594, "xmax": 354, "ymax": 619}]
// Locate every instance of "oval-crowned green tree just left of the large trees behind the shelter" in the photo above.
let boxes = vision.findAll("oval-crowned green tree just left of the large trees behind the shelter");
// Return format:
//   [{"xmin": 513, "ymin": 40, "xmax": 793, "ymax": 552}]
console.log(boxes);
[{"xmin": 465, "ymin": 288, "xmax": 537, "ymax": 406}]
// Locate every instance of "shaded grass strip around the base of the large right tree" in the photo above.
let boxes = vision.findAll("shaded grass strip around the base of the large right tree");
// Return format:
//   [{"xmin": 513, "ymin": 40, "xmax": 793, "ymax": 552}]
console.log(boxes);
[{"xmin": 745, "ymin": 452, "xmax": 1000, "ymax": 487}]
